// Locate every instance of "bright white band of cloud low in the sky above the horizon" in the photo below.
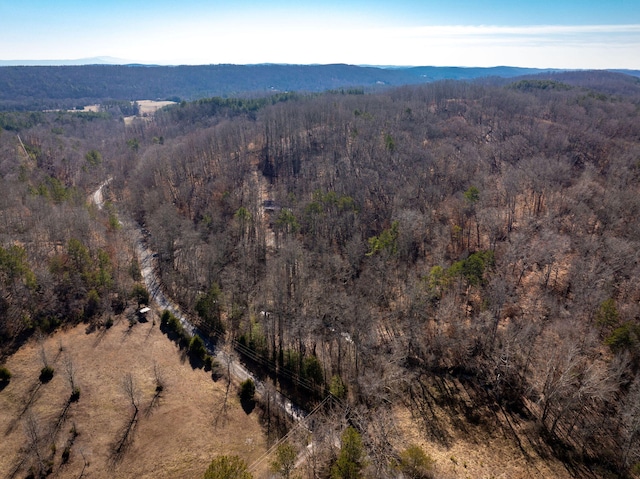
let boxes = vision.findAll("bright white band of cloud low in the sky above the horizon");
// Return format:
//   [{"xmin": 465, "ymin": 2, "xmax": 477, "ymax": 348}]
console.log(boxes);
[{"xmin": 7, "ymin": 19, "xmax": 640, "ymax": 69}]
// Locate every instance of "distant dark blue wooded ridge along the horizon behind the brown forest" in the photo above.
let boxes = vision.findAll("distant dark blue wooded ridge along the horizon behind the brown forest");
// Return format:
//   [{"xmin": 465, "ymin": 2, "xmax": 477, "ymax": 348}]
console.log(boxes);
[{"xmin": 0, "ymin": 62, "xmax": 640, "ymax": 110}]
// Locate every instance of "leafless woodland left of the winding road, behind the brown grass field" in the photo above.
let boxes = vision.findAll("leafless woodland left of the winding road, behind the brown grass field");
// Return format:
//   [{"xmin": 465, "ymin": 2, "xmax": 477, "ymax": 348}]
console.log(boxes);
[{"xmin": 0, "ymin": 113, "xmax": 139, "ymax": 352}]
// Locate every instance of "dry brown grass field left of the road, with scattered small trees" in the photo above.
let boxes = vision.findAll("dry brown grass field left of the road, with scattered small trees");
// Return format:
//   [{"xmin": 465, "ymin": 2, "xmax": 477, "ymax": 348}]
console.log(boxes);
[{"xmin": 0, "ymin": 312, "xmax": 266, "ymax": 478}]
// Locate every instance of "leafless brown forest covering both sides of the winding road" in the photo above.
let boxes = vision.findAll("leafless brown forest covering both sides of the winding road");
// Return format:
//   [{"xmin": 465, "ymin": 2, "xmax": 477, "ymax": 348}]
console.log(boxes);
[{"xmin": 0, "ymin": 72, "xmax": 640, "ymax": 477}]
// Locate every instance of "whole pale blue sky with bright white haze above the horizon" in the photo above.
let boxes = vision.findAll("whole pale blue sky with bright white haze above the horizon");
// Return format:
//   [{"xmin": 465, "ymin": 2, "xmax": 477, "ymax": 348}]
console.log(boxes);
[{"xmin": 0, "ymin": 0, "xmax": 640, "ymax": 69}]
